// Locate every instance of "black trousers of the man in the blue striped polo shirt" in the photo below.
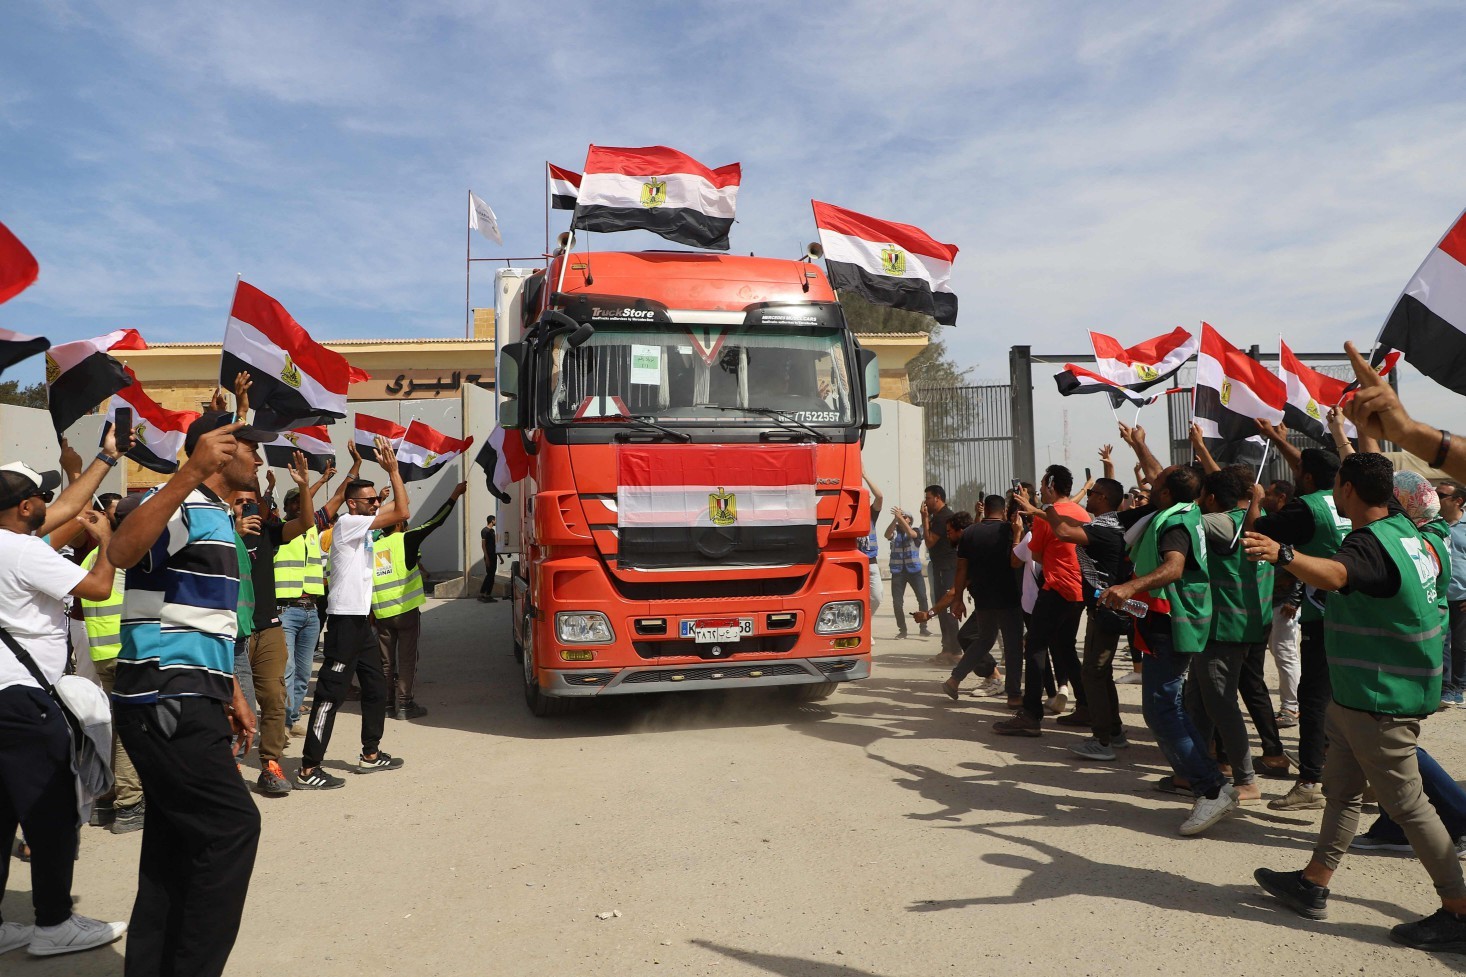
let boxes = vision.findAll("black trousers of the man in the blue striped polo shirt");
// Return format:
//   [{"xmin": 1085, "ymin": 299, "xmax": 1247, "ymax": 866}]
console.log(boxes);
[{"xmin": 114, "ymin": 697, "xmax": 259, "ymax": 977}]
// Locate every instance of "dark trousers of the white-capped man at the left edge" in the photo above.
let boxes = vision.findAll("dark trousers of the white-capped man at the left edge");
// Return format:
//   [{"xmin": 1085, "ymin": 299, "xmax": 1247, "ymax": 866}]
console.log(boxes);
[{"xmin": 0, "ymin": 680, "xmax": 78, "ymax": 926}]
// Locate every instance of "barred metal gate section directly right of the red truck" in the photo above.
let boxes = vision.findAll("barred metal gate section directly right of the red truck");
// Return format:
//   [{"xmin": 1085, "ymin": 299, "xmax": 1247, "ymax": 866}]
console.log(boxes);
[{"xmin": 910, "ymin": 384, "xmax": 1014, "ymax": 512}]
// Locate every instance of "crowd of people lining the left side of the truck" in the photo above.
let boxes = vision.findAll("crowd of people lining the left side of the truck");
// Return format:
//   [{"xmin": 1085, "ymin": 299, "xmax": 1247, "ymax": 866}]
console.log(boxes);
[{"xmin": 0, "ymin": 374, "xmax": 466, "ymax": 976}]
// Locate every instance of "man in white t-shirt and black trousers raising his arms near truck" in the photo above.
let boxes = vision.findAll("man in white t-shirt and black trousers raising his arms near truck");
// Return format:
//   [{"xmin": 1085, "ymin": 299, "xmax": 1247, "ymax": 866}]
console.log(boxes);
[{"xmin": 295, "ymin": 437, "xmax": 412, "ymax": 791}]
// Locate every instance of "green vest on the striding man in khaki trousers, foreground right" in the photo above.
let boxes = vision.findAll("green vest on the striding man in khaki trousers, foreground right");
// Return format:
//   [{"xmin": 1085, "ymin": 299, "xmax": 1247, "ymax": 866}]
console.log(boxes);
[{"xmin": 1324, "ymin": 513, "xmax": 1444, "ymax": 716}]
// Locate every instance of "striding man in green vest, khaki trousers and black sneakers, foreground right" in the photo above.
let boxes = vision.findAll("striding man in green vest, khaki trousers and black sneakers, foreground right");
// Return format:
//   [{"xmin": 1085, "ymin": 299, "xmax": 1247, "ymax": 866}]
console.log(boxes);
[{"xmin": 1246, "ymin": 452, "xmax": 1466, "ymax": 952}]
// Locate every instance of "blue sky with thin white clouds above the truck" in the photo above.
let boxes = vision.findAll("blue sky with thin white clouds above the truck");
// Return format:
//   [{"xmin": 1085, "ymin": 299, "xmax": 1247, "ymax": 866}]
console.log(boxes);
[{"xmin": 0, "ymin": 0, "xmax": 1466, "ymax": 465}]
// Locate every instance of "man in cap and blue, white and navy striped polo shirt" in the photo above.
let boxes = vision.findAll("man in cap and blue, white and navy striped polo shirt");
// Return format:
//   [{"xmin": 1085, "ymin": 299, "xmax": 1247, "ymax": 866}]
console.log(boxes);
[{"xmin": 108, "ymin": 411, "xmax": 274, "ymax": 974}]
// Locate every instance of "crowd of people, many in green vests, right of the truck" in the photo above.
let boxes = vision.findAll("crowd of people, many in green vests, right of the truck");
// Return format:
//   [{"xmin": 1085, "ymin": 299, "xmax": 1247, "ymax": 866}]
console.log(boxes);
[{"xmin": 868, "ymin": 346, "xmax": 1466, "ymax": 952}]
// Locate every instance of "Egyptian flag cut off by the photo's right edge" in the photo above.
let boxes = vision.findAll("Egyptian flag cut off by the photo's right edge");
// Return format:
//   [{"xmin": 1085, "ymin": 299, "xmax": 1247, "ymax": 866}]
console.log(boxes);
[{"xmin": 1377, "ymin": 214, "xmax": 1466, "ymax": 393}]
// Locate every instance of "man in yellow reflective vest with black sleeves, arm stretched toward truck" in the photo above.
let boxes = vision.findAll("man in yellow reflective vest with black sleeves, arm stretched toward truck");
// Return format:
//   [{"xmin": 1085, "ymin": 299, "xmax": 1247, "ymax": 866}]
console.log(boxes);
[{"xmin": 371, "ymin": 481, "xmax": 468, "ymax": 719}]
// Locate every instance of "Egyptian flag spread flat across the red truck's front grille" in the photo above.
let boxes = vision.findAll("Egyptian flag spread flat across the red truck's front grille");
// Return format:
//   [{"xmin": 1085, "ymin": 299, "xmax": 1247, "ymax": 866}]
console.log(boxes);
[{"xmin": 616, "ymin": 444, "xmax": 818, "ymax": 569}]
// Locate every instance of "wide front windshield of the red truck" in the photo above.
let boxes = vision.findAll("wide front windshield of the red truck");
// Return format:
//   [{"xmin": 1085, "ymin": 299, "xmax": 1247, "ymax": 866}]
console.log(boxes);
[{"xmin": 550, "ymin": 323, "xmax": 855, "ymax": 427}]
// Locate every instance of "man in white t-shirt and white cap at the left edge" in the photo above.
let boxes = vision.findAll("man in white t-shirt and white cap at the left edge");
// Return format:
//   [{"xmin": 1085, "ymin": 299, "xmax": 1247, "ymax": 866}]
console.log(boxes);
[{"xmin": 0, "ymin": 464, "xmax": 128, "ymax": 956}]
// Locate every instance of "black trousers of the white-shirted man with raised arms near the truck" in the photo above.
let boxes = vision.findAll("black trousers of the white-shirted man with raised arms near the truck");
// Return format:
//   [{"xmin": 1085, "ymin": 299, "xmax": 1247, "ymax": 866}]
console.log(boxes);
[{"xmin": 301, "ymin": 615, "xmax": 387, "ymax": 770}]
